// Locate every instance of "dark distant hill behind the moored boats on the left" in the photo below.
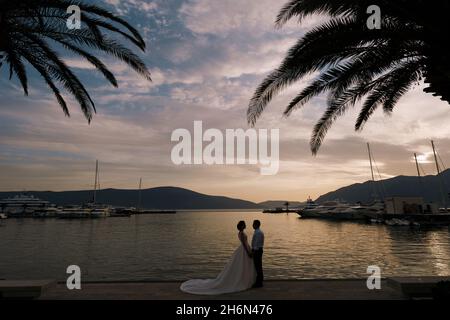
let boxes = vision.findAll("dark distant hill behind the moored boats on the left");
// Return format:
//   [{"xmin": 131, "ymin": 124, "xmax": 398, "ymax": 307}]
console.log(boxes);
[{"xmin": 0, "ymin": 187, "xmax": 261, "ymax": 209}]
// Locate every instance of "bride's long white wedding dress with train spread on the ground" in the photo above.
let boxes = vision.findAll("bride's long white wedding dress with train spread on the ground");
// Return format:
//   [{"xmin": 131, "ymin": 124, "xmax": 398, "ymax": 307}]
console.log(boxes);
[{"xmin": 180, "ymin": 232, "xmax": 256, "ymax": 295}]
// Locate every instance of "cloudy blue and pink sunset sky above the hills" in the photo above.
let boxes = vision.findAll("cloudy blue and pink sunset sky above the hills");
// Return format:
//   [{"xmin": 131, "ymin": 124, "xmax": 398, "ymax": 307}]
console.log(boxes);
[{"xmin": 0, "ymin": 0, "xmax": 450, "ymax": 201}]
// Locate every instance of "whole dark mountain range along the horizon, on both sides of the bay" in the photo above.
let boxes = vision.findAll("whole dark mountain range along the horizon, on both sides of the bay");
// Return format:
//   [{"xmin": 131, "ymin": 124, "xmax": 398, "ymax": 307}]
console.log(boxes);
[{"xmin": 0, "ymin": 169, "xmax": 450, "ymax": 210}]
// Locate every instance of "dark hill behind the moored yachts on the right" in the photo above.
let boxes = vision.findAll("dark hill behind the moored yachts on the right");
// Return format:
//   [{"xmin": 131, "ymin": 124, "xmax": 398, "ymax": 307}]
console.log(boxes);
[{"xmin": 316, "ymin": 169, "xmax": 450, "ymax": 205}]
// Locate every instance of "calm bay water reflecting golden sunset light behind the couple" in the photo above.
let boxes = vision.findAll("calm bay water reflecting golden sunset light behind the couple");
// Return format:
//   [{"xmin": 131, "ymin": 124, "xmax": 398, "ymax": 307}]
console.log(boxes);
[{"xmin": 0, "ymin": 211, "xmax": 450, "ymax": 280}]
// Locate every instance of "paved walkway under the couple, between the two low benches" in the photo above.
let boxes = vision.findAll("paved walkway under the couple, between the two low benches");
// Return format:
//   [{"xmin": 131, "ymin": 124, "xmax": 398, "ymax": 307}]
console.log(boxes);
[{"xmin": 37, "ymin": 279, "xmax": 404, "ymax": 300}]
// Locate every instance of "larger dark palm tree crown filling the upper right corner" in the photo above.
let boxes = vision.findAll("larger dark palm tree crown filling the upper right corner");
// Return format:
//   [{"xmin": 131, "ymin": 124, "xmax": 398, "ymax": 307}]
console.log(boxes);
[{"xmin": 247, "ymin": 0, "xmax": 450, "ymax": 154}]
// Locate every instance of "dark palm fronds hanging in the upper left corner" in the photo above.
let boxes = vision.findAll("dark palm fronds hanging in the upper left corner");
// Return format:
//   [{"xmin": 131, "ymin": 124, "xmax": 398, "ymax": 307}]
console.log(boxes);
[{"xmin": 0, "ymin": 0, "xmax": 151, "ymax": 122}]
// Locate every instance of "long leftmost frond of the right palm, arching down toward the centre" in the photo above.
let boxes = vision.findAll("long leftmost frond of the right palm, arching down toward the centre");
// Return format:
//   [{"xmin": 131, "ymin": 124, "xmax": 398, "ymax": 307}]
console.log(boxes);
[{"xmin": 247, "ymin": 18, "xmax": 419, "ymax": 125}]
